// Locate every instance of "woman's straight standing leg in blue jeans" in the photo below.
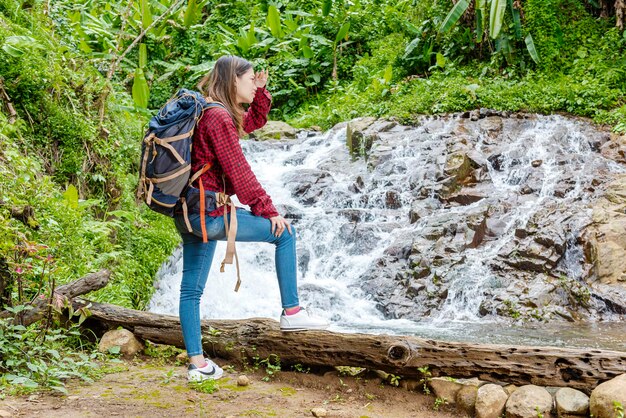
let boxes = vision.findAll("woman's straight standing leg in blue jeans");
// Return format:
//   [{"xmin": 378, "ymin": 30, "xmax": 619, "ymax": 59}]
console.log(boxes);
[{"xmin": 179, "ymin": 234, "xmax": 216, "ymax": 357}]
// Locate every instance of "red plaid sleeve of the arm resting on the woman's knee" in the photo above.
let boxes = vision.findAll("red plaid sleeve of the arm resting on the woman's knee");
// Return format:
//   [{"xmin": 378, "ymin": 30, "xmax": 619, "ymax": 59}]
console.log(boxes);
[{"xmin": 207, "ymin": 109, "xmax": 278, "ymax": 218}]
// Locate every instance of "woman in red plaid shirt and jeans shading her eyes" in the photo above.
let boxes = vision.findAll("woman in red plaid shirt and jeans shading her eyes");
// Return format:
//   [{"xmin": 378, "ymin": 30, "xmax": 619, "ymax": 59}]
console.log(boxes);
[{"xmin": 175, "ymin": 56, "xmax": 328, "ymax": 381}]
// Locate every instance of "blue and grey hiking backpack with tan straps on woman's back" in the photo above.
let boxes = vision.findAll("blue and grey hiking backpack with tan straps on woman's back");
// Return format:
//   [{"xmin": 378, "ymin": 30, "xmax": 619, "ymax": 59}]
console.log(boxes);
[{"xmin": 137, "ymin": 89, "xmax": 241, "ymax": 291}]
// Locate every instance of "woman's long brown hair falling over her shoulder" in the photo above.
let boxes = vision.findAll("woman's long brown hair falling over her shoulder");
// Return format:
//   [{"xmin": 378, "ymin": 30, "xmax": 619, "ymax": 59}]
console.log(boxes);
[{"xmin": 198, "ymin": 55, "xmax": 252, "ymax": 136}]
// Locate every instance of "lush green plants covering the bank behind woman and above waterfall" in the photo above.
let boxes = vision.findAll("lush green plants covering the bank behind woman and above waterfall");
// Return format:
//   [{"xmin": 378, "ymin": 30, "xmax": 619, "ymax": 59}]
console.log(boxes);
[{"xmin": 0, "ymin": 0, "xmax": 626, "ymax": 309}]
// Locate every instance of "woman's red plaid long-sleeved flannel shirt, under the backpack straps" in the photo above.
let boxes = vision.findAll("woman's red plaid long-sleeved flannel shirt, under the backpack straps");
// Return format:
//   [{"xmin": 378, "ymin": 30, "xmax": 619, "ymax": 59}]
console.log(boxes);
[{"xmin": 191, "ymin": 87, "xmax": 278, "ymax": 218}]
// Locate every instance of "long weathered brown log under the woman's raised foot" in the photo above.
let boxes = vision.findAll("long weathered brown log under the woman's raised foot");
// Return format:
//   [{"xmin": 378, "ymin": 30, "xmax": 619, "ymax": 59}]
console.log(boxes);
[{"xmin": 74, "ymin": 300, "xmax": 626, "ymax": 391}]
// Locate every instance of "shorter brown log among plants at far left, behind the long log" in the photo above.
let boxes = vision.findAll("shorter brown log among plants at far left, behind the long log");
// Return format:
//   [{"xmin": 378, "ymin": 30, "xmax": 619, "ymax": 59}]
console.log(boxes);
[{"xmin": 0, "ymin": 270, "xmax": 111, "ymax": 326}]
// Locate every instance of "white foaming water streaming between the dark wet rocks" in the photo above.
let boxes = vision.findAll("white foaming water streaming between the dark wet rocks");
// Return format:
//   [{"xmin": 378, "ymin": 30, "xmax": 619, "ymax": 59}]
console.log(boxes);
[{"xmin": 149, "ymin": 116, "xmax": 622, "ymax": 337}]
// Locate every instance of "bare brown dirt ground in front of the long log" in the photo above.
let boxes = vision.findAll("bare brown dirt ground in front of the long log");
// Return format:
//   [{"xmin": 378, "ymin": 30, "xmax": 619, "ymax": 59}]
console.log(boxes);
[{"xmin": 0, "ymin": 358, "xmax": 464, "ymax": 418}]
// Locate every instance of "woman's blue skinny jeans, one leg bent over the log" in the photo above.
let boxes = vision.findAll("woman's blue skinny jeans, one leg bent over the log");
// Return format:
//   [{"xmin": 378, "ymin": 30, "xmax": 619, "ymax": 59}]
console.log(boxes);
[{"xmin": 174, "ymin": 209, "xmax": 299, "ymax": 357}]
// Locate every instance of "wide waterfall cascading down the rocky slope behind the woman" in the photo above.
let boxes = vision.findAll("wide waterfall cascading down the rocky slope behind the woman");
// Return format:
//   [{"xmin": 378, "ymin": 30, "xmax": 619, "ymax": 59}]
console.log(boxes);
[{"xmin": 149, "ymin": 112, "xmax": 623, "ymax": 344}]
